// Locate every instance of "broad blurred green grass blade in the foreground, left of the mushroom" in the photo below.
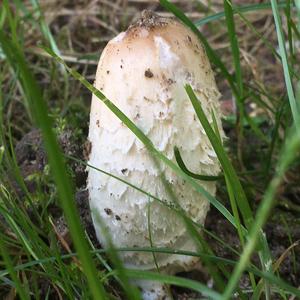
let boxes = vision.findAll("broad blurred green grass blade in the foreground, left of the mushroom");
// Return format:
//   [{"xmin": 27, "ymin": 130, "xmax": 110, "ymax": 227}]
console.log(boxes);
[{"xmin": 0, "ymin": 32, "xmax": 106, "ymax": 299}]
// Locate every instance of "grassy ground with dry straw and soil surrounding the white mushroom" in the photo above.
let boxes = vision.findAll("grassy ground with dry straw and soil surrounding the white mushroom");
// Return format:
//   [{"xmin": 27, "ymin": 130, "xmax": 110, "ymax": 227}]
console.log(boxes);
[{"xmin": 0, "ymin": 0, "xmax": 300, "ymax": 300}]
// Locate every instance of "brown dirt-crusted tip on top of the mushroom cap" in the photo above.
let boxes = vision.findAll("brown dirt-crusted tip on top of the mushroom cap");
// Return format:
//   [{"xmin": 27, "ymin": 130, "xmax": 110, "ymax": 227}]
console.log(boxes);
[{"xmin": 128, "ymin": 9, "xmax": 171, "ymax": 31}]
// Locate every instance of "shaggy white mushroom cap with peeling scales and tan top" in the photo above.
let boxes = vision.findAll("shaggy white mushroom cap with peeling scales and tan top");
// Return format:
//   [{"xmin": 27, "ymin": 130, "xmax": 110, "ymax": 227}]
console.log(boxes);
[{"xmin": 88, "ymin": 12, "xmax": 223, "ymax": 298}]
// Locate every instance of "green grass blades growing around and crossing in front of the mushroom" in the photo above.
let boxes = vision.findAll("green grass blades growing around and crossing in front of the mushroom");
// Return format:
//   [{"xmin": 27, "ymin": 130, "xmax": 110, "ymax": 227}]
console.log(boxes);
[{"xmin": 0, "ymin": 0, "xmax": 300, "ymax": 299}]
